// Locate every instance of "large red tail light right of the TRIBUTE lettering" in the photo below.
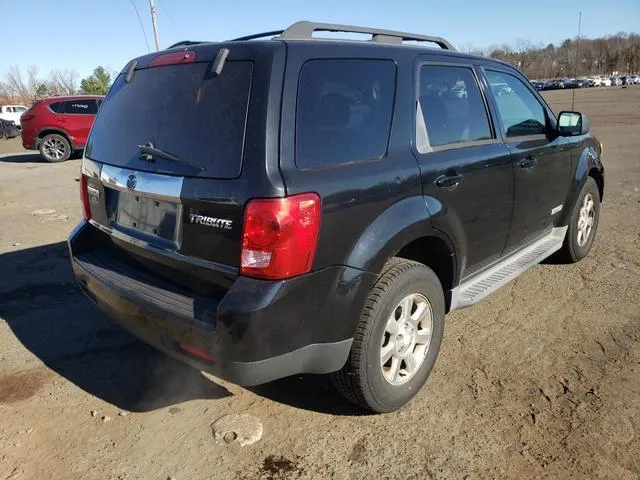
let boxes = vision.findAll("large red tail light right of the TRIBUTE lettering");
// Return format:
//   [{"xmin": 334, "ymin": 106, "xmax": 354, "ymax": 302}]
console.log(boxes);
[{"xmin": 240, "ymin": 193, "xmax": 320, "ymax": 280}]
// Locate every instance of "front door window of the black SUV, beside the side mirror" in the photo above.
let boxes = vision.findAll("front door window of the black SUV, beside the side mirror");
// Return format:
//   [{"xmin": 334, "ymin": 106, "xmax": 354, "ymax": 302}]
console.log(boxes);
[{"xmin": 486, "ymin": 70, "xmax": 547, "ymax": 137}]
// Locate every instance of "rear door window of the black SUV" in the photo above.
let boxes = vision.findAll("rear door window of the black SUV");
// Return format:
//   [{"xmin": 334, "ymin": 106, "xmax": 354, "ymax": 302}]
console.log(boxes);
[{"xmin": 416, "ymin": 65, "xmax": 492, "ymax": 151}]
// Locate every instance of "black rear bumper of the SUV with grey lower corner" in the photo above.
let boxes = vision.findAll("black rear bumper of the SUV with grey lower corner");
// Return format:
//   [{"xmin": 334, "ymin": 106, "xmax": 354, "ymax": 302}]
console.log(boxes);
[{"xmin": 69, "ymin": 222, "xmax": 376, "ymax": 386}]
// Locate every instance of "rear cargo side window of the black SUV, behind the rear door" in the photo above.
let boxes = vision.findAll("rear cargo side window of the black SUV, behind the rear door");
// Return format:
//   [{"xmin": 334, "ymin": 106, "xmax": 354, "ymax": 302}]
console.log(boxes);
[{"xmin": 296, "ymin": 60, "xmax": 396, "ymax": 168}]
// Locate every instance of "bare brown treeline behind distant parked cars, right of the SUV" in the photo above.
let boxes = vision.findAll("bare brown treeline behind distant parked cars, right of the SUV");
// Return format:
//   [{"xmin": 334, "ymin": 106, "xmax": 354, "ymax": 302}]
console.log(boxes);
[{"xmin": 464, "ymin": 32, "xmax": 640, "ymax": 79}]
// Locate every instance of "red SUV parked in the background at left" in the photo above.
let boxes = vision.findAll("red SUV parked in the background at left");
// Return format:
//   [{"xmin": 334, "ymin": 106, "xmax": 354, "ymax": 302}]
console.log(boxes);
[{"xmin": 20, "ymin": 95, "xmax": 104, "ymax": 162}]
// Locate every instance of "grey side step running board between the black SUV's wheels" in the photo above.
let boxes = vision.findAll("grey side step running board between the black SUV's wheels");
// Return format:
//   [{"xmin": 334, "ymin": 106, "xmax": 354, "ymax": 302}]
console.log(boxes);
[{"xmin": 451, "ymin": 227, "xmax": 567, "ymax": 310}]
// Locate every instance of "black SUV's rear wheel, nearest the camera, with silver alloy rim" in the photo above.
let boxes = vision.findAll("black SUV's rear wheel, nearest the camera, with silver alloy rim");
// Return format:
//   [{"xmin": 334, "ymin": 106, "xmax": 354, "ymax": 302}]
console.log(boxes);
[{"xmin": 332, "ymin": 258, "xmax": 445, "ymax": 413}]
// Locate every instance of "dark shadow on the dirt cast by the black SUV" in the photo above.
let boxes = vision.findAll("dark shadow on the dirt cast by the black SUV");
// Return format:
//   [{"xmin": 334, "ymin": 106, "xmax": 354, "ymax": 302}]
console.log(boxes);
[{"xmin": 0, "ymin": 242, "xmax": 365, "ymax": 415}]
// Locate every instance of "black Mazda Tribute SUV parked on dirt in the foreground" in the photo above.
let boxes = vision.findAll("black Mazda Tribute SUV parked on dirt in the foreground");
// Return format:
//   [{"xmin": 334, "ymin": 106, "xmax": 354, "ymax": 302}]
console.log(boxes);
[{"xmin": 69, "ymin": 22, "xmax": 604, "ymax": 412}]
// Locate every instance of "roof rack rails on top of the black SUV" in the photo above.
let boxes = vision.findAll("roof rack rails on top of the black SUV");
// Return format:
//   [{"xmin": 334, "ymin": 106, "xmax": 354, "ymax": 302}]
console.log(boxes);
[{"xmin": 274, "ymin": 21, "xmax": 455, "ymax": 51}]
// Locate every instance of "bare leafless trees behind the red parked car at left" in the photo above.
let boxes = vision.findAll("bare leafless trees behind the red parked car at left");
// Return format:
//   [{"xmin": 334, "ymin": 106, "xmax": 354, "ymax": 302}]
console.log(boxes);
[{"xmin": 0, "ymin": 65, "xmax": 115, "ymax": 105}]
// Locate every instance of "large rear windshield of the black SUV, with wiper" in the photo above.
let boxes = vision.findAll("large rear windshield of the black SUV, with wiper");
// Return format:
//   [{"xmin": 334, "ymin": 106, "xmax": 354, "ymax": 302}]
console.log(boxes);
[{"xmin": 86, "ymin": 61, "xmax": 253, "ymax": 178}]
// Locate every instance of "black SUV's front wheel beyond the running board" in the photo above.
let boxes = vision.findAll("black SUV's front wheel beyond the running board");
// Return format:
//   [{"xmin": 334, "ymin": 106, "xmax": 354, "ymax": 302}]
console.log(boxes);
[{"xmin": 556, "ymin": 177, "xmax": 600, "ymax": 263}]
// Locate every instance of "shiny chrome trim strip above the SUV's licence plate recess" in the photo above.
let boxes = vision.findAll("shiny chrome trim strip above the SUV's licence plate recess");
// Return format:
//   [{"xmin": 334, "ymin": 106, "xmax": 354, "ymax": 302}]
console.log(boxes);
[{"xmin": 100, "ymin": 165, "xmax": 184, "ymax": 203}]
